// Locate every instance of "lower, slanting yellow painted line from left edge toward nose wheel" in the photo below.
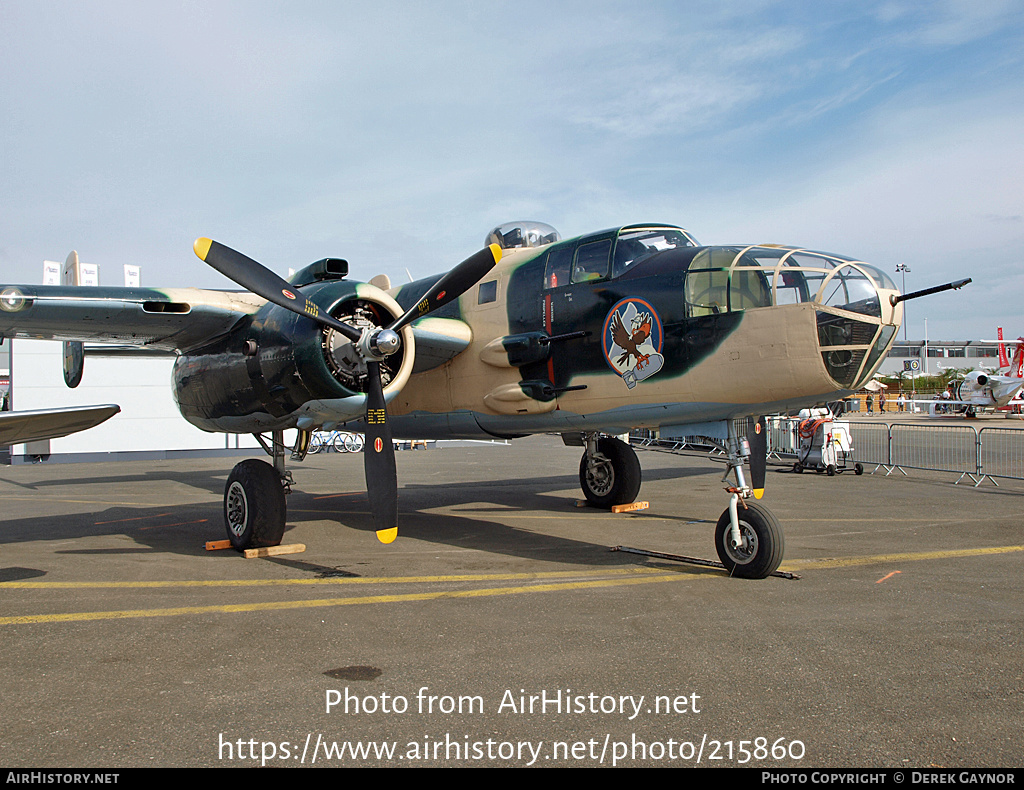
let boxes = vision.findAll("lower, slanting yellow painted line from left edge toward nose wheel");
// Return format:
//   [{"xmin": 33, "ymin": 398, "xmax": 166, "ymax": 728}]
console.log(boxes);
[{"xmin": 0, "ymin": 573, "xmax": 690, "ymax": 625}]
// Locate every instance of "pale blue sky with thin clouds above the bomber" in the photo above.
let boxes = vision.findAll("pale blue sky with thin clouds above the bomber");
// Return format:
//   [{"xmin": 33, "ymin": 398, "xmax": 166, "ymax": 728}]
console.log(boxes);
[{"xmin": 0, "ymin": 0, "xmax": 1024, "ymax": 339}]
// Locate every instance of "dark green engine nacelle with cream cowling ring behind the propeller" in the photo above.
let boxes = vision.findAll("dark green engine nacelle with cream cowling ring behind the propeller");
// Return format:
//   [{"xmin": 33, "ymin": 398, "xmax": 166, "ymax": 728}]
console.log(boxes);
[{"xmin": 173, "ymin": 281, "xmax": 415, "ymax": 433}]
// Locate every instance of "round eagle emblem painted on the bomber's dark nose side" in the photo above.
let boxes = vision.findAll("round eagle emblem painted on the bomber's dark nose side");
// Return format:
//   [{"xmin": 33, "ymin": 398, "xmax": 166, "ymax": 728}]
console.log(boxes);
[{"xmin": 602, "ymin": 298, "xmax": 665, "ymax": 389}]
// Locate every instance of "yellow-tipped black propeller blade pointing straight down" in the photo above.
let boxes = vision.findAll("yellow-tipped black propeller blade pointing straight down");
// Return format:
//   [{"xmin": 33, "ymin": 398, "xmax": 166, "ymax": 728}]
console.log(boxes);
[{"xmin": 362, "ymin": 360, "xmax": 398, "ymax": 543}]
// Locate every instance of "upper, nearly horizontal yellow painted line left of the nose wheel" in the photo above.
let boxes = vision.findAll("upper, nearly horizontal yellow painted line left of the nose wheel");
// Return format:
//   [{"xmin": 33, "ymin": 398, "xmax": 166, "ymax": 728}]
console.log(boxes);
[{"xmin": 0, "ymin": 568, "xmax": 665, "ymax": 589}]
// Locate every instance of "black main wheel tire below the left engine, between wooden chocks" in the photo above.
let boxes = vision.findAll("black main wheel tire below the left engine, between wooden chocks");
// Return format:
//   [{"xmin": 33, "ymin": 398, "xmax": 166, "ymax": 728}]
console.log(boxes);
[{"xmin": 224, "ymin": 458, "xmax": 287, "ymax": 551}]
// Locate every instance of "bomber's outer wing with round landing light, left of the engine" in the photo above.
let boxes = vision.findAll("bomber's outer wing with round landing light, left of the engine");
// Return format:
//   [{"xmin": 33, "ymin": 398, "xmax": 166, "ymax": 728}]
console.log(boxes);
[{"xmin": 0, "ymin": 285, "xmax": 264, "ymax": 351}]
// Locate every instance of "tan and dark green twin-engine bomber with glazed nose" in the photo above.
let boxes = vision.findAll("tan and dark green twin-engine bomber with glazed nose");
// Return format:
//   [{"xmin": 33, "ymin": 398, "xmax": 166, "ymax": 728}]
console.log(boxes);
[{"xmin": 0, "ymin": 222, "xmax": 959, "ymax": 578}]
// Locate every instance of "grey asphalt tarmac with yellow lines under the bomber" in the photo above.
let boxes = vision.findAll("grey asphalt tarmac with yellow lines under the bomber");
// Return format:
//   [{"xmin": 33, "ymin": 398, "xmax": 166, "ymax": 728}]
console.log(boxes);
[{"xmin": 0, "ymin": 436, "xmax": 1024, "ymax": 770}]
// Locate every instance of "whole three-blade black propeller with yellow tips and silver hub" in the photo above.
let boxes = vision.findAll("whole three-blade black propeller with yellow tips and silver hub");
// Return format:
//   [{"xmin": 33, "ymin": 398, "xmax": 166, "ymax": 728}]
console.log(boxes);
[{"xmin": 193, "ymin": 239, "xmax": 502, "ymax": 543}]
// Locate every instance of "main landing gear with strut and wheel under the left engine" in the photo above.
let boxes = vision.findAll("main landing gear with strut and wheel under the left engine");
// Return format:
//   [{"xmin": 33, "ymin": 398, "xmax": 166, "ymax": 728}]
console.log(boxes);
[{"xmin": 224, "ymin": 430, "xmax": 301, "ymax": 551}]
